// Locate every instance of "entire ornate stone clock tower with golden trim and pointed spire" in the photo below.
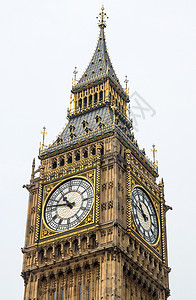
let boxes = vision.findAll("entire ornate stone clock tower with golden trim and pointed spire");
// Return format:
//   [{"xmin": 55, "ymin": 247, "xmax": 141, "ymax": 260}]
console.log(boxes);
[{"xmin": 22, "ymin": 7, "xmax": 170, "ymax": 300}]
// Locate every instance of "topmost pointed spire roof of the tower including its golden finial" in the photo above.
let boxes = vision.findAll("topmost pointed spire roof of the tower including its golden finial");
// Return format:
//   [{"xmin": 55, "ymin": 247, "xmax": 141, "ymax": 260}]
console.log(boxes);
[{"xmin": 73, "ymin": 7, "xmax": 122, "ymax": 90}]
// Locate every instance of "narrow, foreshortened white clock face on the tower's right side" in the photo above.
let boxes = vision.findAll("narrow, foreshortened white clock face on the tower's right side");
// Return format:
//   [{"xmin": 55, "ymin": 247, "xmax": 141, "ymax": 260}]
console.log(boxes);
[{"xmin": 131, "ymin": 187, "xmax": 159, "ymax": 244}]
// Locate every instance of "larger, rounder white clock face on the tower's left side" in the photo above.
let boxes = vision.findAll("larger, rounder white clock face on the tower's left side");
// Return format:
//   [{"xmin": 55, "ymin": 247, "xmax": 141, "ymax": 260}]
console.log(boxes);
[{"xmin": 44, "ymin": 178, "xmax": 94, "ymax": 231}]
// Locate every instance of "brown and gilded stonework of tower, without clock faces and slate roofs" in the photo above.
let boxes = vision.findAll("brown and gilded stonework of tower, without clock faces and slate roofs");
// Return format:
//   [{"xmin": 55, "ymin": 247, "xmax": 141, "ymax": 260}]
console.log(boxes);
[{"xmin": 22, "ymin": 5, "xmax": 170, "ymax": 300}]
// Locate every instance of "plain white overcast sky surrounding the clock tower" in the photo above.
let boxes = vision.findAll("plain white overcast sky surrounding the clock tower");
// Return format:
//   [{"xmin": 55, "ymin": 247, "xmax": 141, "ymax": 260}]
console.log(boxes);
[{"xmin": 0, "ymin": 0, "xmax": 196, "ymax": 300}]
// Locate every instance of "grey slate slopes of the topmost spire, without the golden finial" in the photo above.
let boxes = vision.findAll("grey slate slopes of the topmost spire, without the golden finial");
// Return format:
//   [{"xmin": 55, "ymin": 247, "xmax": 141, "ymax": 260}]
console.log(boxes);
[{"xmin": 75, "ymin": 27, "xmax": 117, "ymax": 88}]
